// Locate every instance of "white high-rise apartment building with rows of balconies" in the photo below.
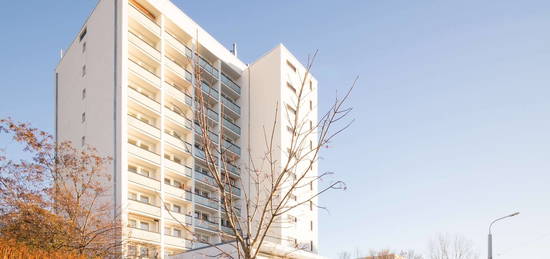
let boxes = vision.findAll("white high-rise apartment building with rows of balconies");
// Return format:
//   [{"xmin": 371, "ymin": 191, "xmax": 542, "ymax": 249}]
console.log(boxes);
[{"xmin": 55, "ymin": 0, "xmax": 318, "ymax": 258}]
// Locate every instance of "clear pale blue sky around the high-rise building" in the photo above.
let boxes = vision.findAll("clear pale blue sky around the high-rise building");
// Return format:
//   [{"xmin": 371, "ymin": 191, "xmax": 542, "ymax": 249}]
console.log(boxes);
[{"xmin": 0, "ymin": 0, "xmax": 550, "ymax": 259}]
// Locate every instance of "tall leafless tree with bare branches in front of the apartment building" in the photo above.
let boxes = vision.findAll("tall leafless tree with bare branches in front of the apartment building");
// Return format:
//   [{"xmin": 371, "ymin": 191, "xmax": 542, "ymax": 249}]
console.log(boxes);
[{"xmin": 167, "ymin": 38, "xmax": 357, "ymax": 259}]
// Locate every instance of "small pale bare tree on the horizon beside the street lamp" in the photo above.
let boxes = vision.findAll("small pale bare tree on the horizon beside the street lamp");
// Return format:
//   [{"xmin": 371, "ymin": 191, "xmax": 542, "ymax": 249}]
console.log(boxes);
[{"xmin": 429, "ymin": 234, "xmax": 478, "ymax": 259}]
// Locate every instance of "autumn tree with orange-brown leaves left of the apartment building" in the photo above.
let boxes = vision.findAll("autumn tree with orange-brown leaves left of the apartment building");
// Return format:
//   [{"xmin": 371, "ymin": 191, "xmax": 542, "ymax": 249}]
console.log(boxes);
[{"xmin": 0, "ymin": 119, "xmax": 121, "ymax": 257}]
